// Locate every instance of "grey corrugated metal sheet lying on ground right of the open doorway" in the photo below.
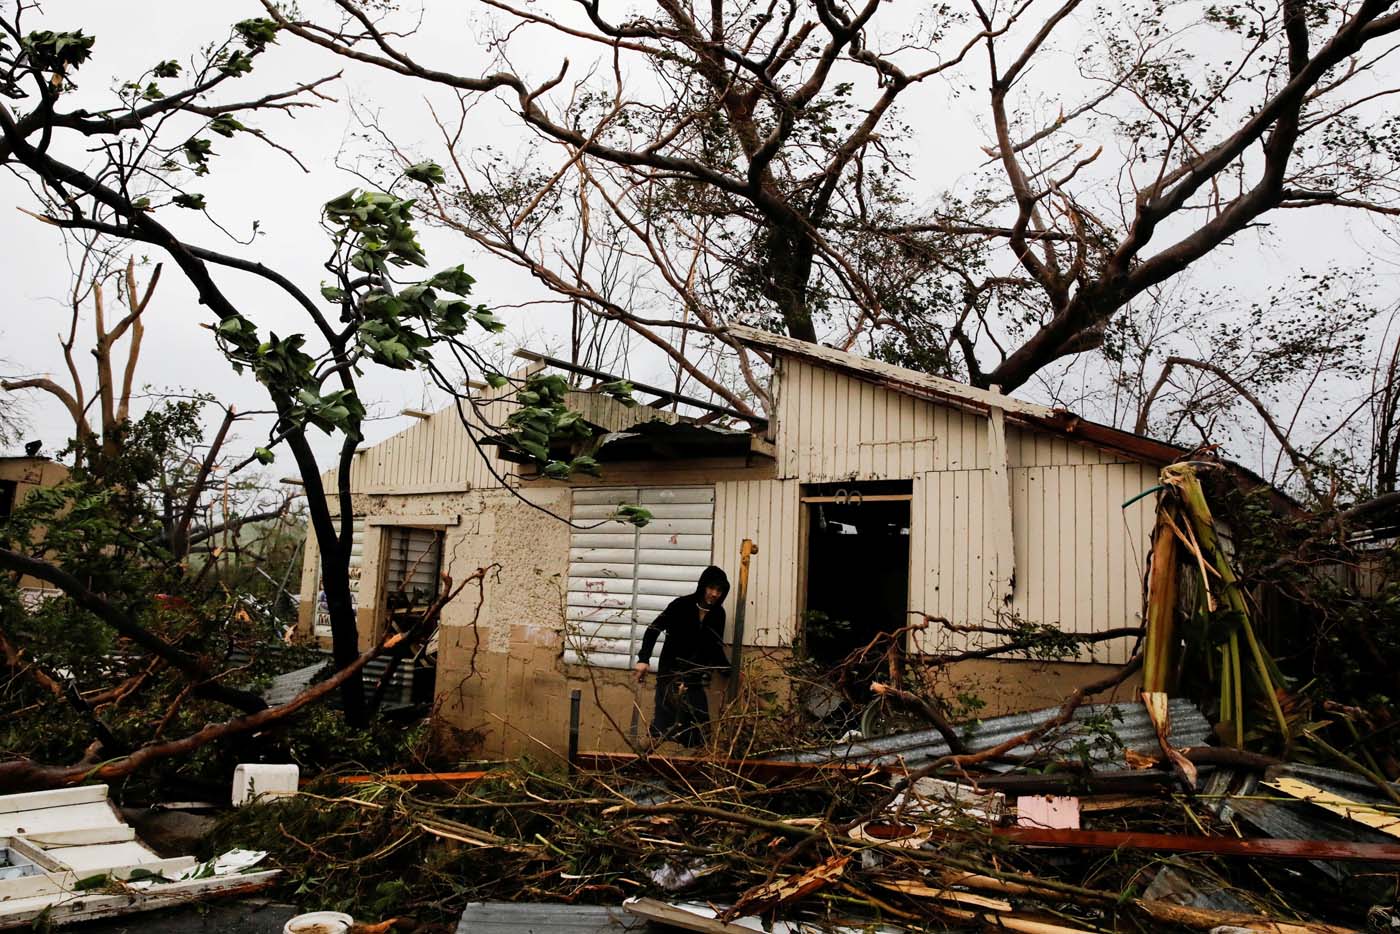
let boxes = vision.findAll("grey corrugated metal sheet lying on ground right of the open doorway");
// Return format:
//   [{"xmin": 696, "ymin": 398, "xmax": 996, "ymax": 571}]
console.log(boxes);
[{"xmin": 792, "ymin": 697, "xmax": 1211, "ymax": 770}]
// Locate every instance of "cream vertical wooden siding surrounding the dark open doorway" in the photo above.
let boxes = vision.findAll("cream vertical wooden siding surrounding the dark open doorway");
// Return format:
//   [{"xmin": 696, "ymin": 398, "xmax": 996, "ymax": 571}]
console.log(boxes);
[{"xmin": 750, "ymin": 357, "xmax": 1158, "ymax": 662}]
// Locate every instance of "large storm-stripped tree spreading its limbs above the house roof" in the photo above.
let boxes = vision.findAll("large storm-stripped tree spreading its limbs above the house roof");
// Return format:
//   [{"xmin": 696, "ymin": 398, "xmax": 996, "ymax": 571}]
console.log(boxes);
[{"xmin": 263, "ymin": 0, "xmax": 1400, "ymax": 406}]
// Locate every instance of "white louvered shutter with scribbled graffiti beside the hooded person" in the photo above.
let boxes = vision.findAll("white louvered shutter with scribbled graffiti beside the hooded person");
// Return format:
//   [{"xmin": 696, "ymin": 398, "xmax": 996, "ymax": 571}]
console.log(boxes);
[{"xmin": 564, "ymin": 486, "xmax": 714, "ymax": 668}]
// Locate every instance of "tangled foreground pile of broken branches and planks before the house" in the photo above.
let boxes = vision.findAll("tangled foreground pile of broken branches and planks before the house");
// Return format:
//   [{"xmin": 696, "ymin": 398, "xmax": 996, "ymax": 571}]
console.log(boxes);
[{"xmin": 207, "ymin": 691, "xmax": 1400, "ymax": 934}]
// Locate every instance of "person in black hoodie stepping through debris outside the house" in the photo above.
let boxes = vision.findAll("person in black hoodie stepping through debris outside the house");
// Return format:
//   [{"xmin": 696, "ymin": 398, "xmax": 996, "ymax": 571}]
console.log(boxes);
[{"xmin": 636, "ymin": 566, "xmax": 729, "ymax": 746}]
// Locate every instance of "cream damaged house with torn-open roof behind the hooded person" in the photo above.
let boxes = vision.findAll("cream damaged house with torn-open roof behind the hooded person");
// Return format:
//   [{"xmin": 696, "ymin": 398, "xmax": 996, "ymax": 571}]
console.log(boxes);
[{"xmin": 302, "ymin": 328, "xmax": 1183, "ymax": 755}]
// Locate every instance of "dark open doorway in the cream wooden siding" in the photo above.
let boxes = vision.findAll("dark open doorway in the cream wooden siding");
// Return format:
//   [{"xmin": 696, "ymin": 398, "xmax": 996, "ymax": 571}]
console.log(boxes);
[{"xmin": 802, "ymin": 482, "xmax": 910, "ymax": 676}]
